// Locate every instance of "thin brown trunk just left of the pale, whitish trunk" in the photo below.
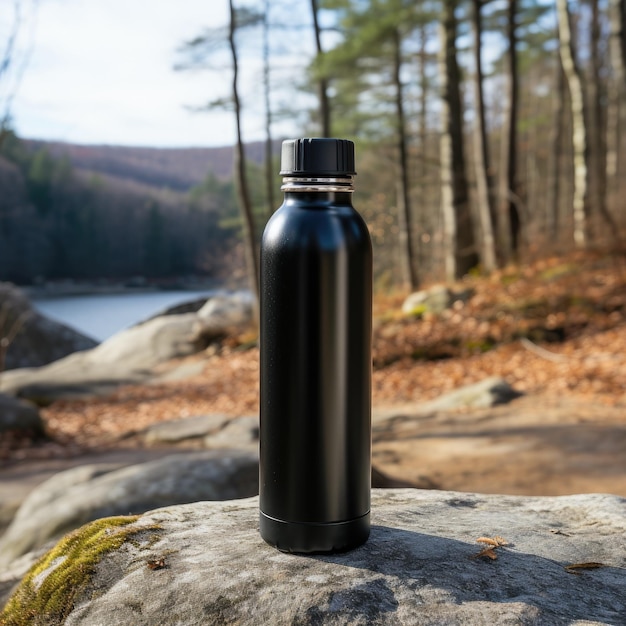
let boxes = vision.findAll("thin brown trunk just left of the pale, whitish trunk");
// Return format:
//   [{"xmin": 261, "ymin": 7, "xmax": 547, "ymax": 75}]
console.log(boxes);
[{"xmin": 546, "ymin": 62, "xmax": 565, "ymax": 241}]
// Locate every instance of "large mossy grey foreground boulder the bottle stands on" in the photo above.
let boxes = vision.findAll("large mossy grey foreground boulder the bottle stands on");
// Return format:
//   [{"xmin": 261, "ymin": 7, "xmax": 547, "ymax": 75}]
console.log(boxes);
[{"xmin": 0, "ymin": 490, "xmax": 626, "ymax": 626}]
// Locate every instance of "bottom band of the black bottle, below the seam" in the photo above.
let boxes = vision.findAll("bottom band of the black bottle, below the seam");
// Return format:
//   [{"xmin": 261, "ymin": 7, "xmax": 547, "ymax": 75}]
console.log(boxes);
[{"xmin": 259, "ymin": 511, "xmax": 370, "ymax": 554}]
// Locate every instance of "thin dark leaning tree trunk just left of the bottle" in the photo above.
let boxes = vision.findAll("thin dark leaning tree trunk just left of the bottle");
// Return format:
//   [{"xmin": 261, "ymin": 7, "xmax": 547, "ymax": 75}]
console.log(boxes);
[{"xmin": 228, "ymin": 0, "xmax": 259, "ymax": 302}]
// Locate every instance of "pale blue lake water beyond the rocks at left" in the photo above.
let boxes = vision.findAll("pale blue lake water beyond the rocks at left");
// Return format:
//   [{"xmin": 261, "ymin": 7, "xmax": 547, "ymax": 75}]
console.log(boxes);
[{"xmin": 33, "ymin": 291, "xmax": 221, "ymax": 341}]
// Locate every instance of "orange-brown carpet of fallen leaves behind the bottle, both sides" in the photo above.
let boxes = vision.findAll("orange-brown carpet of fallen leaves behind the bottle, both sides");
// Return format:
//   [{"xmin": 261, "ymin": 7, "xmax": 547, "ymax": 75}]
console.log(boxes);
[{"xmin": 0, "ymin": 247, "xmax": 626, "ymax": 459}]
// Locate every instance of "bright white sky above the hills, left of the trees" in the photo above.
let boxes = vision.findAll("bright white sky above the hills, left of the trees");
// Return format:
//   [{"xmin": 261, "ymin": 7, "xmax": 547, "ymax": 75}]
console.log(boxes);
[{"xmin": 0, "ymin": 0, "xmax": 294, "ymax": 147}]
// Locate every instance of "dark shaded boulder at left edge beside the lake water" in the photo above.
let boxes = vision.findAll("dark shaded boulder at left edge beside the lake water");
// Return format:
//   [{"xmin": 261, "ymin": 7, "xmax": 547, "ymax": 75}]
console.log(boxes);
[{"xmin": 0, "ymin": 283, "xmax": 98, "ymax": 370}]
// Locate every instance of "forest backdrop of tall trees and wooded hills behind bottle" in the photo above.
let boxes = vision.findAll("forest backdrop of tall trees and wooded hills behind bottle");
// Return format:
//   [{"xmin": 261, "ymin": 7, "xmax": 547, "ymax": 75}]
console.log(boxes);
[{"xmin": 0, "ymin": 0, "xmax": 626, "ymax": 290}]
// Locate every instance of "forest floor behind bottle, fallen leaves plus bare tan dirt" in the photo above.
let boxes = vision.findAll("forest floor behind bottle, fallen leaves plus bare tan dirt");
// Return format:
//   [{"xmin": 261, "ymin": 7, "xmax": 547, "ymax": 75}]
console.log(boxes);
[{"xmin": 0, "ymin": 253, "xmax": 626, "ymax": 496}]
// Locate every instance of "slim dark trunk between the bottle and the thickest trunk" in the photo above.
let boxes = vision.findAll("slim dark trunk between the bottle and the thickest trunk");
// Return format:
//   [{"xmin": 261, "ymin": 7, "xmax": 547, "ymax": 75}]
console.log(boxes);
[{"xmin": 393, "ymin": 28, "xmax": 419, "ymax": 289}]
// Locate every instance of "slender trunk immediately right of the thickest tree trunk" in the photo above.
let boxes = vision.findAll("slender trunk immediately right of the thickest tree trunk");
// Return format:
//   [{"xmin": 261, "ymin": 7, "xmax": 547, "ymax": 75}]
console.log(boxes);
[{"xmin": 472, "ymin": 0, "xmax": 496, "ymax": 272}]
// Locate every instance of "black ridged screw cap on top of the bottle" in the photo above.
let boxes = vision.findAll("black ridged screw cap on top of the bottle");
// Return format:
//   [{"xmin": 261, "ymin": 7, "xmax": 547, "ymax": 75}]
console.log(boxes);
[{"xmin": 280, "ymin": 137, "xmax": 356, "ymax": 178}]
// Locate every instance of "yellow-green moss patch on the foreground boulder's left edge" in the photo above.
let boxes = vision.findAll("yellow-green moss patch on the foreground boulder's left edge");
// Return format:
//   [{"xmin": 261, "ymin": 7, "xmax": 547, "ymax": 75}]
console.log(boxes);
[{"xmin": 0, "ymin": 515, "xmax": 148, "ymax": 626}]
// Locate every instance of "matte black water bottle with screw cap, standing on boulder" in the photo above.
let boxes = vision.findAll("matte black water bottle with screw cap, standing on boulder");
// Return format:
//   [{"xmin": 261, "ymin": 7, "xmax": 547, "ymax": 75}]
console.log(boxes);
[{"xmin": 260, "ymin": 139, "xmax": 372, "ymax": 553}]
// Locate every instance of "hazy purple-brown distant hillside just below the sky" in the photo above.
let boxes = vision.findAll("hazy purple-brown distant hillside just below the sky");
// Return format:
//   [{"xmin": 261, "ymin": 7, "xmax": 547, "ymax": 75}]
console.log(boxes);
[{"xmin": 24, "ymin": 139, "xmax": 278, "ymax": 191}]
